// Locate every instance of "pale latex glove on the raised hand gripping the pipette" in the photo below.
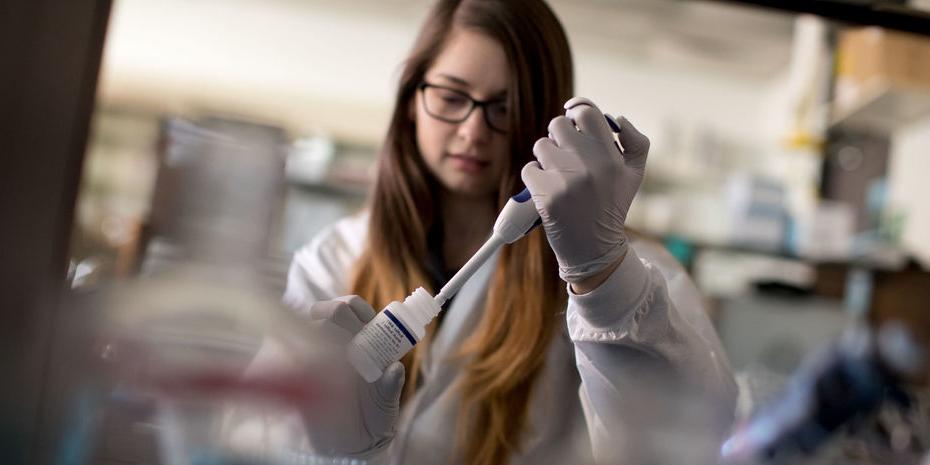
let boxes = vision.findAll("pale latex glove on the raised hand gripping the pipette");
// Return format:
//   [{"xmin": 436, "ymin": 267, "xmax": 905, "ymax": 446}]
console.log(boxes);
[{"xmin": 521, "ymin": 97, "xmax": 649, "ymax": 283}]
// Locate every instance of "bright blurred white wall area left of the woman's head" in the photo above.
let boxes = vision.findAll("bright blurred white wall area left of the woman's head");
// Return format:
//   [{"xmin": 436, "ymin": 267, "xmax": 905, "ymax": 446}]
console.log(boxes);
[{"xmin": 100, "ymin": 0, "xmax": 422, "ymax": 142}]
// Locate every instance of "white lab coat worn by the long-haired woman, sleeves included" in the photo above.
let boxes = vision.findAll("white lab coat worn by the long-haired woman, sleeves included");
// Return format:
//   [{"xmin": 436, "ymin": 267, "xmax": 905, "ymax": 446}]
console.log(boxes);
[{"xmin": 270, "ymin": 213, "xmax": 736, "ymax": 465}]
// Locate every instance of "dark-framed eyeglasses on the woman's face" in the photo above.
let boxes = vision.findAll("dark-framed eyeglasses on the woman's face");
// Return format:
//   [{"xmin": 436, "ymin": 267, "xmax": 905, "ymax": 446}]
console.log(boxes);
[{"xmin": 417, "ymin": 82, "xmax": 510, "ymax": 133}]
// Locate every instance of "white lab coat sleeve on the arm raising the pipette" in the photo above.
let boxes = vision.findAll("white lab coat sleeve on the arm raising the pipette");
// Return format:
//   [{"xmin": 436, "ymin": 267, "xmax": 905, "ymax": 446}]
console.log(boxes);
[{"xmin": 567, "ymin": 247, "xmax": 736, "ymax": 464}]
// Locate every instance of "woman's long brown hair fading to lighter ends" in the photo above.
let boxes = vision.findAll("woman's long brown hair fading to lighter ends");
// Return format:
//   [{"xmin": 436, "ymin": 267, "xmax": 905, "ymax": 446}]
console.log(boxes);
[{"xmin": 351, "ymin": 0, "xmax": 573, "ymax": 465}]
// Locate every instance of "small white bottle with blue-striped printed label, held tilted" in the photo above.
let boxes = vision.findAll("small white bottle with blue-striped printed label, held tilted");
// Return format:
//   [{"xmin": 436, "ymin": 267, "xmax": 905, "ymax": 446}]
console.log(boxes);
[{"xmin": 348, "ymin": 287, "xmax": 440, "ymax": 383}]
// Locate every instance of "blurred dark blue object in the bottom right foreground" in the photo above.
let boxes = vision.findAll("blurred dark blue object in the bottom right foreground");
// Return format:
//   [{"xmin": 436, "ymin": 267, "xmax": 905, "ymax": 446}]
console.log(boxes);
[{"xmin": 721, "ymin": 323, "xmax": 930, "ymax": 465}]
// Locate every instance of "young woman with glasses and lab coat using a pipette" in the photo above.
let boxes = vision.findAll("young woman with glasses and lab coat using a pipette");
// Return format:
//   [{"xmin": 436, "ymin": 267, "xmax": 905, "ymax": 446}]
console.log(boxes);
[{"xmin": 285, "ymin": 0, "xmax": 735, "ymax": 465}]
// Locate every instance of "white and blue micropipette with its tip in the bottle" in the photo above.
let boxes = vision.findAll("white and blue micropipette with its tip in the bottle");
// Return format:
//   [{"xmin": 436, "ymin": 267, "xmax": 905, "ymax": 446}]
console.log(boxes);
[{"xmin": 433, "ymin": 113, "xmax": 620, "ymax": 307}]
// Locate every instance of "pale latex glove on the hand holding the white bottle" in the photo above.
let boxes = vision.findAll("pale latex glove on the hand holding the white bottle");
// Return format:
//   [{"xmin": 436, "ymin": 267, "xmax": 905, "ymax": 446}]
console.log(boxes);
[{"xmin": 304, "ymin": 296, "xmax": 404, "ymax": 458}]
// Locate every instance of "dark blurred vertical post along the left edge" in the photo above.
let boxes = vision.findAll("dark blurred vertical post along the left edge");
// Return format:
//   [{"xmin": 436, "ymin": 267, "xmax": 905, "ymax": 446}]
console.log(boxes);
[{"xmin": 0, "ymin": 0, "xmax": 110, "ymax": 465}]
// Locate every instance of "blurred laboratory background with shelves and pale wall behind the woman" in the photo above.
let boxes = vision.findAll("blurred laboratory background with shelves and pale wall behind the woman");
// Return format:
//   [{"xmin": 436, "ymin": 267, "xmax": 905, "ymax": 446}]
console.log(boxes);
[{"xmin": 5, "ymin": 0, "xmax": 930, "ymax": 463}]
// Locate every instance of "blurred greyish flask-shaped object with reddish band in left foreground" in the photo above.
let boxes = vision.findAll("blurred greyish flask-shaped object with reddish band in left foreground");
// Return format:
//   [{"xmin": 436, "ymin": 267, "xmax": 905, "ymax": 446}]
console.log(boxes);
[{"xmin": 47, "ymin": 118, "xmax": 358, "ymax": 465}]
